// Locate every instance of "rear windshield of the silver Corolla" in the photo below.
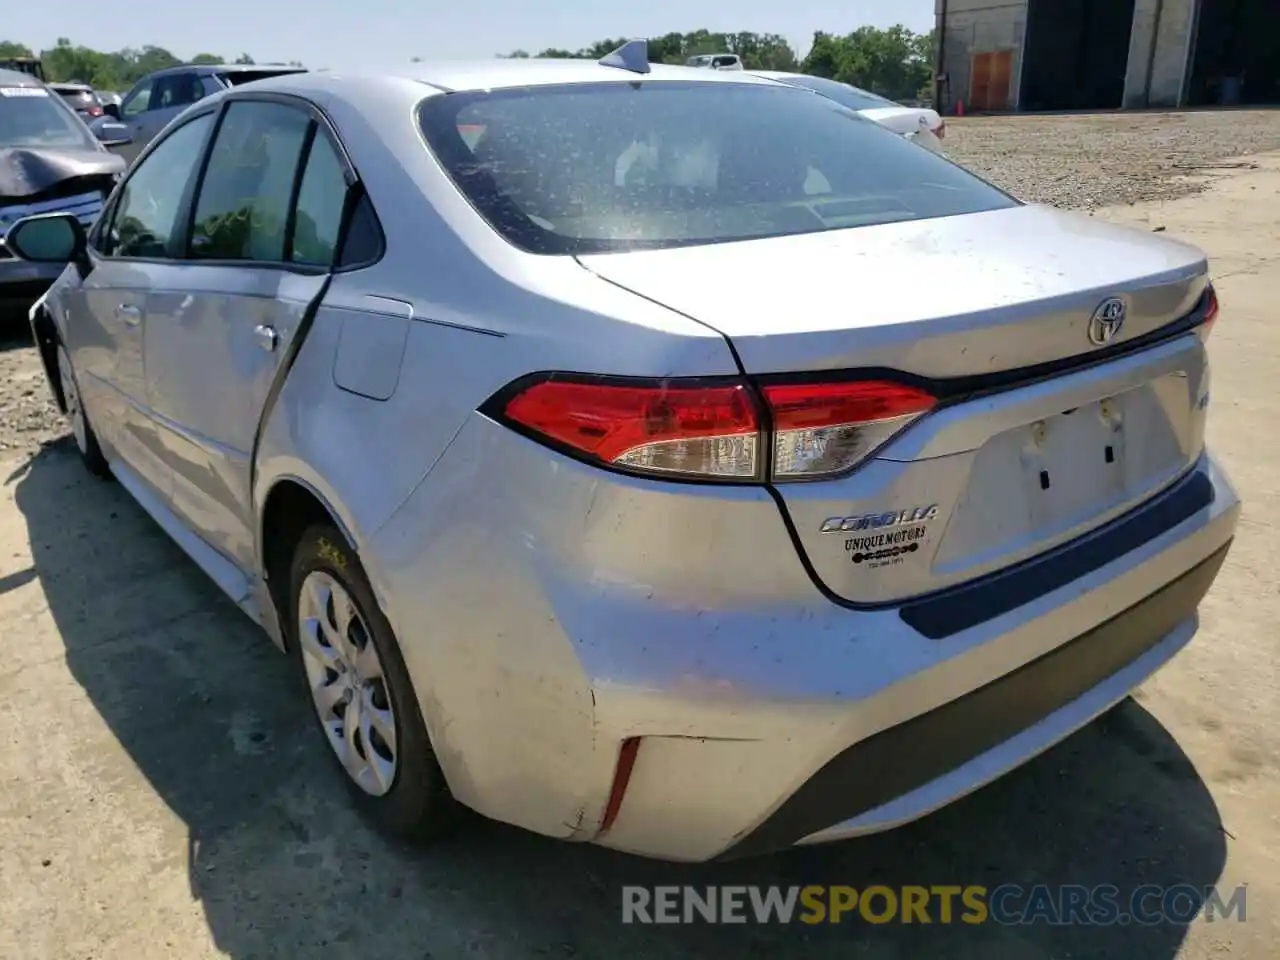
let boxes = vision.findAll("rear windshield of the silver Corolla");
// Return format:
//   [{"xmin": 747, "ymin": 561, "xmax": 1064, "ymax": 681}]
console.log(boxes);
[{"xmin": 419, "ymin": 81, "xmax": 1016, "ymax": 255}]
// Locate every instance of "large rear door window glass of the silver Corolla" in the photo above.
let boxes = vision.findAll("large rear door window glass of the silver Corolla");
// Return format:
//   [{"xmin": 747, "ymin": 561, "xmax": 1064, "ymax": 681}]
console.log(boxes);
[{"xmin": 191, "ymin": 100, "xmax": 311, "ymax": 262}]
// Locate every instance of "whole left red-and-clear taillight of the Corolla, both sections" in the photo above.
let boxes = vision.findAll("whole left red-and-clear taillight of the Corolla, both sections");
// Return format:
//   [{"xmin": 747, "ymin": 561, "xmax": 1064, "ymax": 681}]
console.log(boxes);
[{"xmin": 500, "ymin": 375, "xmax": 936, "ymax": 481}]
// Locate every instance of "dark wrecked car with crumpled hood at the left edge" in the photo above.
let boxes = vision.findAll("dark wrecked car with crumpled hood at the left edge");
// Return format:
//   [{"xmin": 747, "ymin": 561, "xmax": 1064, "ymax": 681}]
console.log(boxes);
[{"xmin": 0, "ymin": 69, "xmax": 124, "ymax": 320}]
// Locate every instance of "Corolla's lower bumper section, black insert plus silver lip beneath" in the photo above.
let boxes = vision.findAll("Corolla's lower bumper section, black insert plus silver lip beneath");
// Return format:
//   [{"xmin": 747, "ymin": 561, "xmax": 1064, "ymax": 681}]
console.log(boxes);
[{"xmin": 721, "ymin": 544, "xmax": 1230, "ymax": 859}]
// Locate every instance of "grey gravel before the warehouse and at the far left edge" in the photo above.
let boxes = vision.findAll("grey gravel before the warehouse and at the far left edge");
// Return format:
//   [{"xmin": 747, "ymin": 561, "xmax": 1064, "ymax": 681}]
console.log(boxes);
[{"xmin": 0, "ymin": 110, "xmax": 1280, "ymax": 458}]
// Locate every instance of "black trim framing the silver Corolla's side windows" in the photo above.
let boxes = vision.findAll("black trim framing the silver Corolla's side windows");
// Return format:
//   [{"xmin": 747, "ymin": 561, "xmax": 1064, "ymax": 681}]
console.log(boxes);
[{"xmin": 88, "ymin": 91, "xmax": 387, "ymax": 276}]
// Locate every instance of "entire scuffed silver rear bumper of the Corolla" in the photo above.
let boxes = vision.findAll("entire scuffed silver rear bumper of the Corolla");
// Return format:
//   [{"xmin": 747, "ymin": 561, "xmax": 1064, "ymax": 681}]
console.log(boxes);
[{"xmin": 362, "ymin": 419, "xmax": 1239, "ymax": 861}]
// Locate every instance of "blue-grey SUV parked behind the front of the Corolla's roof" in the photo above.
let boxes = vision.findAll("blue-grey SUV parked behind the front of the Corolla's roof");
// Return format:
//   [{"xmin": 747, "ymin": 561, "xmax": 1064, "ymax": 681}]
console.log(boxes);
[{"xmin": 105, "ymin": 64, "xmax": 306, "ymax": 163}]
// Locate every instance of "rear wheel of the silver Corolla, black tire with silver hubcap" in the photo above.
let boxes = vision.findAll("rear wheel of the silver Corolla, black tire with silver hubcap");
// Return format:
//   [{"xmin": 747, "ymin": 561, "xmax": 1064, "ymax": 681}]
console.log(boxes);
[{"xmin": 287, "ymin": 524, "xmax": 460, "ymax": 841}]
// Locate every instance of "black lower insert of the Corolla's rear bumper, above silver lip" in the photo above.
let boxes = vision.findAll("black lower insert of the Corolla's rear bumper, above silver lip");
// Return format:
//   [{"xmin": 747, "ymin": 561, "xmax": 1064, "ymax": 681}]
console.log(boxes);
[{"xmin": 717, "ymin": 543, "xmax": 1231, "ymax": 860}]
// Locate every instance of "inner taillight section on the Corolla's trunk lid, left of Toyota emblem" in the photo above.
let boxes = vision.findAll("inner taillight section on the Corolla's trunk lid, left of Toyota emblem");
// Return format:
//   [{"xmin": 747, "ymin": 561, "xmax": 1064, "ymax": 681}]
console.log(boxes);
[{"xmin": 764, "ymin": 380, "xmax": 937, "ymax": 480}]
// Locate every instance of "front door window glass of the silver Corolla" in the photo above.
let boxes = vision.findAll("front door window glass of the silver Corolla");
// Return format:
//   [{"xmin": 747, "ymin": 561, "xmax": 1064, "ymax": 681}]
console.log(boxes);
[{"xmin": 99, "ymin": 114, "xmax": 214, "ymax": 257}]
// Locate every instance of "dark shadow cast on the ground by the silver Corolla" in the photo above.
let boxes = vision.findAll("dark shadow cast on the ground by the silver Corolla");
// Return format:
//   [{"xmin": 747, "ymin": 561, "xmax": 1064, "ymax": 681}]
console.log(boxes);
[{"xmin": 10, "ymin": 440, "xmax": 1226, "ymax": 960}]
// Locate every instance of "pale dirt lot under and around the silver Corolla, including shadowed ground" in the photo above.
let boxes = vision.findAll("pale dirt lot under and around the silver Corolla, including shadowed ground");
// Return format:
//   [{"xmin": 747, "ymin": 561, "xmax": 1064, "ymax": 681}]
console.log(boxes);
[{"xmin": 0, "ymin": 114, "xmax": 1280, "ymax": 960}]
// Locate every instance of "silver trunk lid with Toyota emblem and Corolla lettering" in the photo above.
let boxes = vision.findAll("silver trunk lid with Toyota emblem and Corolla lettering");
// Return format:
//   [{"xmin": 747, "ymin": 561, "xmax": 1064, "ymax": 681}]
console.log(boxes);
[{"xmin": 582, "ymin": 206, "xmax": 1208, "ymax": 604}]
